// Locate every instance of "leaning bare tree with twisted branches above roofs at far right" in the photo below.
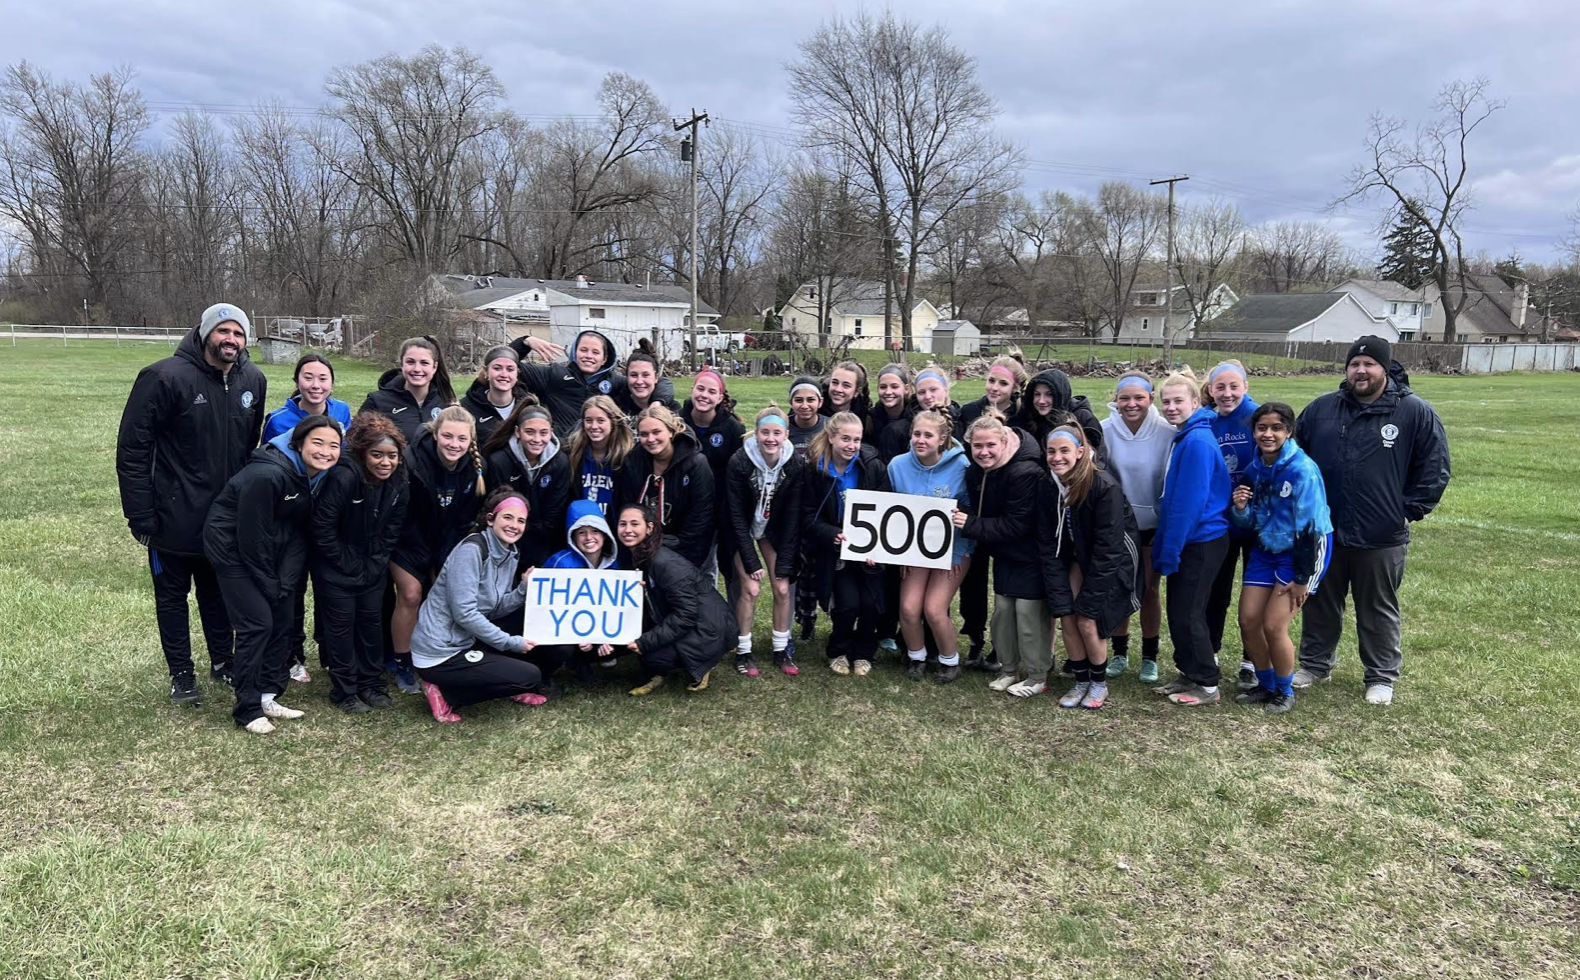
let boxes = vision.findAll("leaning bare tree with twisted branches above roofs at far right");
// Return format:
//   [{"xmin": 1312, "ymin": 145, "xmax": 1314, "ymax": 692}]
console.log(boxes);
[{"xmin": 1335, "ymin": 77, "xmax": 1506, "ymax": 343}]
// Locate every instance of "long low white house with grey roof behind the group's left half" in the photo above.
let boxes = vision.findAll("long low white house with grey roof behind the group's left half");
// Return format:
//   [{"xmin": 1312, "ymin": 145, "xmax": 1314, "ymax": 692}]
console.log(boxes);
[{"xmin": 435, "ymin": 275, "xmax": 719, "ymax": 357}]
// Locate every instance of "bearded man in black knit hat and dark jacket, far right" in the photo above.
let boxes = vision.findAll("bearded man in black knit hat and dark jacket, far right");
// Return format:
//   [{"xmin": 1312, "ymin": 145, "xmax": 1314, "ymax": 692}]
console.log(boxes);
[{"xmin": 1294, "ymin": 337, "xmax": 1449, "ymax": 705}]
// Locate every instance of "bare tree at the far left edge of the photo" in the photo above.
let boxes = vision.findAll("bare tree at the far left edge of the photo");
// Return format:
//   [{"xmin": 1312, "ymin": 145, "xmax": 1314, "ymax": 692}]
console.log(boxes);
[{"xmin": 0, "ymin": 62, "xmax": 150, "ymax": 305}]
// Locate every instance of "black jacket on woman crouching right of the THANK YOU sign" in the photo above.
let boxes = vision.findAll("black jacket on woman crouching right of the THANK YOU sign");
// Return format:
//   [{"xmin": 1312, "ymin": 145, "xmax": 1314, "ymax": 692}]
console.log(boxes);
[{"xmin": 621, "ymin": 542, "xmax": 735, "ymax": 678}]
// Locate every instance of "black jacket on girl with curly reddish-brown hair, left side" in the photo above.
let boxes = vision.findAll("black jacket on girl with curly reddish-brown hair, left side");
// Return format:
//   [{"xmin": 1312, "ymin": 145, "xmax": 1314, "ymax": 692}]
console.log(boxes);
[{"xmin": 308, "ymin": 454, "xmax": 411, "ymax": 596}]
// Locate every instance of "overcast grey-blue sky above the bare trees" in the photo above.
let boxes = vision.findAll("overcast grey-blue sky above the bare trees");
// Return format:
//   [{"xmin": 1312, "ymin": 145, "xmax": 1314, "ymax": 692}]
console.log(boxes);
[{"xmin": 0, "ymin": 0, "xmax": 1580, "ymax": 261}]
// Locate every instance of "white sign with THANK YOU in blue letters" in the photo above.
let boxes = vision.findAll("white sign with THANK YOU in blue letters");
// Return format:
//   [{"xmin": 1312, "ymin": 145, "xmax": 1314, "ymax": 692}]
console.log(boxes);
[{"xmin": 521, "ymin": 569, "xmax": 641, "ymax": 646}]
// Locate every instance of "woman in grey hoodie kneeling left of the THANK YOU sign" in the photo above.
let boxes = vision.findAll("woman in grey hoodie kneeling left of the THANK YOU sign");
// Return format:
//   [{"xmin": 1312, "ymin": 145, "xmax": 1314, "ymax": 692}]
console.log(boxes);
[{"xmin": 411, "ymin": 487, "xmax": 547, "ymax": 722}]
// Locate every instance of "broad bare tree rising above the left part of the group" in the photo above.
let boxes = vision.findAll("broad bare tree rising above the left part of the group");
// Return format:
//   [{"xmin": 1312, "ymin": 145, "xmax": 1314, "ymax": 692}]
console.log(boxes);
[{"xmin": 324, "ymin": 44, "xmax": 504, "ymax": 272}]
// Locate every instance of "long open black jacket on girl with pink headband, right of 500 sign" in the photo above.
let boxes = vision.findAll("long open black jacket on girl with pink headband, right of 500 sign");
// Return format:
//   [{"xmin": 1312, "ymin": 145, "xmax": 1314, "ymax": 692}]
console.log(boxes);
[{"xmin": 1036, "ymin": 469, "xmax": 1146, "ymax": 637}]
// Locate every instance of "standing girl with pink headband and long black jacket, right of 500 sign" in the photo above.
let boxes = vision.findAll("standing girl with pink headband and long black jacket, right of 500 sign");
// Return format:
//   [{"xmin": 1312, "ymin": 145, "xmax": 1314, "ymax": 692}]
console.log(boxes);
[{"xmin": 1038, "ymin": 425, "xmax": 1142, "ymax": 708}]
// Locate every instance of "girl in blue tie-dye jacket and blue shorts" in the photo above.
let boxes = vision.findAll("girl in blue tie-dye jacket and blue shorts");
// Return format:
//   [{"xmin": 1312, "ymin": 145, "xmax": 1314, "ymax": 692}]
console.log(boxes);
[{"xmin": 1229, "ymin": 401, "xmax": 1334, "ymax": 714}]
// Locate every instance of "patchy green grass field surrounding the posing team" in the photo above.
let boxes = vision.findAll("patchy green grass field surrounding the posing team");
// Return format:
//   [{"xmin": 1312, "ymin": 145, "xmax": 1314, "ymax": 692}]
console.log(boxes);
[{"xmin": 0, "ymin": 343, "xmax": 1580, "ymax": 980}]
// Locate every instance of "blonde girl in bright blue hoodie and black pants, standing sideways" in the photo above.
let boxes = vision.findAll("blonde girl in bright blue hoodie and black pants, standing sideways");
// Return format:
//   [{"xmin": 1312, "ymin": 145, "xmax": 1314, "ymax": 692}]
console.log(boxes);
[{"xmin": 1152, "ymin": 368, "xmax": 1229, "ymax": 707}]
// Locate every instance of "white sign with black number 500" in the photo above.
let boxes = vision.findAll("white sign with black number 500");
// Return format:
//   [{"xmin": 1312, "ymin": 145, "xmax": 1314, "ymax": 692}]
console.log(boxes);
[{"xmin": 839, "ymin": 490, "xmax": 954, "ymax": 569}]
